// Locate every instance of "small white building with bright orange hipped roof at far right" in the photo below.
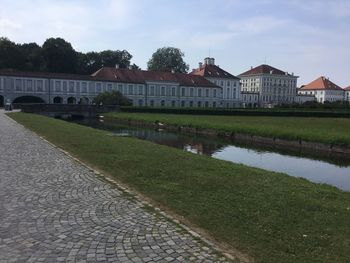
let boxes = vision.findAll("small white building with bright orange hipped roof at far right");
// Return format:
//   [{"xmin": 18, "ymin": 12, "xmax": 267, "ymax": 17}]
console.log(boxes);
[{"xmin": 298, "ymin": 77, "xmax": 345, "ymax": 103}]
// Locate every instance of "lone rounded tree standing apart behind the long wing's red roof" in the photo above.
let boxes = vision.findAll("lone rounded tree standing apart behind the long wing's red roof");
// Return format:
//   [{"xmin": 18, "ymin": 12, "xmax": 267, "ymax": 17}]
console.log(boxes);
[{"xmin": 147, "ymin": 47, "xmax": 189, "ymax": 73}]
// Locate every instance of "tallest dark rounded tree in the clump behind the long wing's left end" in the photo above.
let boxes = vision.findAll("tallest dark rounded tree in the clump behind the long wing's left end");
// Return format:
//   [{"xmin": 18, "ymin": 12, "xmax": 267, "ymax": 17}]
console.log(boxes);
[{"xmin": 42, "ymin": 38, "xmax": 78, "ymax": 73}]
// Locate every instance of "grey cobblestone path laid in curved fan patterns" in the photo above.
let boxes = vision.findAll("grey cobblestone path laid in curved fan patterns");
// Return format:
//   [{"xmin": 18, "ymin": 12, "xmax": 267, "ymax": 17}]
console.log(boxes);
[{"xmin": 0, "ymin": 111, "xmax": 227, "ymax": 262}]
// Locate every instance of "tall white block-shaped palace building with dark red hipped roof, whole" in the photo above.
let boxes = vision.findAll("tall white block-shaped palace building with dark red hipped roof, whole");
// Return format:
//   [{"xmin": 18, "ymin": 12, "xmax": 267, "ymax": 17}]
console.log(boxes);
[{"xmin": 239, "ymin": 65, "xmax": 298, "ymax": 107}]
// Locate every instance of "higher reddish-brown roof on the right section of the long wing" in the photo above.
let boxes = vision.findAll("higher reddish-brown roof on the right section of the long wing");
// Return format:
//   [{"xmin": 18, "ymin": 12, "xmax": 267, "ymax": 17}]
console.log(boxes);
[{"xmin": 91, "ymin": 67, "xmax": 218, "ymax": 88}]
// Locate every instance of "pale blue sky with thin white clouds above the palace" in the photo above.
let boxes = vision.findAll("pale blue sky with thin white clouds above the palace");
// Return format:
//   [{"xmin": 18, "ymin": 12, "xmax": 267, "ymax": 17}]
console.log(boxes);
[{"xmin": 0, "ymin": 0, "xmax": 350, "ymax": 87}]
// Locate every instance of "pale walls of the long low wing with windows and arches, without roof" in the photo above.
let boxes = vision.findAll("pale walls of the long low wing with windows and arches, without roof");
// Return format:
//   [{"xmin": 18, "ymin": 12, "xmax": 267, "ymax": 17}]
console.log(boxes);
[{"xmin": 0, "ymin": 76, "xmax": 221, "ymax": 107}]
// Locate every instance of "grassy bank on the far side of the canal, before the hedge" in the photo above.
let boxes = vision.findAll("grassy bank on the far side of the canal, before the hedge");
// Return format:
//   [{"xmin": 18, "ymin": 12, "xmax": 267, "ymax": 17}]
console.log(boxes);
[{"xmin": 106, "ymin": 112, "xmax": 350, "ymax": 145}]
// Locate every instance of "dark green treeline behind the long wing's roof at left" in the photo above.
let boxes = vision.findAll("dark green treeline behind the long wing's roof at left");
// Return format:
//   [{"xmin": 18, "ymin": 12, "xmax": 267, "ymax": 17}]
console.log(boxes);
[{"xmin": 0, "ymin": 37, "xmax": 139, "ymax": 74}]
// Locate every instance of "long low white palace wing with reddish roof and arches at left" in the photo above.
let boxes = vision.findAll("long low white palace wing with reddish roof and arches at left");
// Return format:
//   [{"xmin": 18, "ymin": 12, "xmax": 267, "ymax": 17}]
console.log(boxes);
[{"xmin": 0, "ymin": 67, "xmax": 222, "ymax": 107}]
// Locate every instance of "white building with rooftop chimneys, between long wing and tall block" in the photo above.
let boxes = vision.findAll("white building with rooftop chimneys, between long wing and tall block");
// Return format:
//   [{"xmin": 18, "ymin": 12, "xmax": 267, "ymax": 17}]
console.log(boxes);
[{"xmin": 190, "ymin": 57, "xmax": 241, "ymax": 108}]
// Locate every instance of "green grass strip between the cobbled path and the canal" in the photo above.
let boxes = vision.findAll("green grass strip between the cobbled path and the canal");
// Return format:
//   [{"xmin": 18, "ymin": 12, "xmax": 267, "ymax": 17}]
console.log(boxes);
[{"xmin": 10, "ymin": 113, "xmax": 350, "ymax": 263}]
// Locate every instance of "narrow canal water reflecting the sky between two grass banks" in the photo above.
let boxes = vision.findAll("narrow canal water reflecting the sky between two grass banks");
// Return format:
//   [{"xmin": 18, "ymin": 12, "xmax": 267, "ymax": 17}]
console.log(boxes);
[{"xmin": 71, "ymin": 120, "xmax": 350, "ymax": 191}]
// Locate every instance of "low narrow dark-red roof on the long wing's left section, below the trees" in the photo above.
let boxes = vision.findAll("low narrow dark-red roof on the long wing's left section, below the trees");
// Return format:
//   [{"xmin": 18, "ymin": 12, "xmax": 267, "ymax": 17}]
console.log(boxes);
[{"xmin": 0, "ymin": 69, "xmax": 91, "ymax": 80}]
